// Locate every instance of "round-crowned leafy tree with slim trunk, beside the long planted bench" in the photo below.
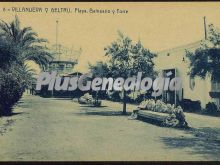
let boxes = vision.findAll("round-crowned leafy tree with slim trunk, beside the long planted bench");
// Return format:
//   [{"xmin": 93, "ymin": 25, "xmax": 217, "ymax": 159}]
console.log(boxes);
[{"xmin": 104, "ymin": 32, "xmax": 156, "ymax": 114}]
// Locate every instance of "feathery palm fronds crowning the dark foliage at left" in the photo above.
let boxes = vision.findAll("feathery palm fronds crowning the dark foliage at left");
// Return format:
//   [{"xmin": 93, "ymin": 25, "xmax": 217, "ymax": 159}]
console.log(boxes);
[{"xmin": 0, "ymin": 16, "xmax": 52, "ymax": 69}]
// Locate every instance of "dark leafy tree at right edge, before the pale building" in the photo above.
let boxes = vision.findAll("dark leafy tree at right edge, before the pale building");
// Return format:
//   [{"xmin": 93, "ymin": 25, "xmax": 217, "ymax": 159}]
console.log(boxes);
[{"xmin": 186, "ymin": 24, "xmax": 220, "ymax": 82}]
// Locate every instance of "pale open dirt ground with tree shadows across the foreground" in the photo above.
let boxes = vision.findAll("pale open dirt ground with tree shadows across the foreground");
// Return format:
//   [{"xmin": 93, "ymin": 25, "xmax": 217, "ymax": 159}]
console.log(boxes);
[{"xmin": 0, "ymin": 96, "xmax": 220, "ymax": 161}]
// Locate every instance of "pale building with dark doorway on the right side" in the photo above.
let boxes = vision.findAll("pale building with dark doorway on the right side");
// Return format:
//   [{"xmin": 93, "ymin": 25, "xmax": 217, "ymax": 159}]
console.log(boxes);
[{"xmin": 154, "ymin": 41, "xmax": 220, "ymax": 108}]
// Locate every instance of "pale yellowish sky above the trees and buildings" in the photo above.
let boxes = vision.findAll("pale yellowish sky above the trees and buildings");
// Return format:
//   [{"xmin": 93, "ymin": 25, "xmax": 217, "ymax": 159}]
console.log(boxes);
[{"xmin": 0, "ymin": 2, "xmax": 220, "ymax": 72}]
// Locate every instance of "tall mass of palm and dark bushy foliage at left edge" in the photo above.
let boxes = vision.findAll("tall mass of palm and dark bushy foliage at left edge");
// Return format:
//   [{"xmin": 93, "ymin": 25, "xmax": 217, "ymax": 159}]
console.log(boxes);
[{"xmin": 0, "ymin": 16, "xmax": 52, "ymax": 115}]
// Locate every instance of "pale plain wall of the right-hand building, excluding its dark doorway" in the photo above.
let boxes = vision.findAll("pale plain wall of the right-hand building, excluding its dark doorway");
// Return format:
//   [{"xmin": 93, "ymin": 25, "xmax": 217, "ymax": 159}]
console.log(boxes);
[{"xmin": 154, "ymin": 41, "xmax": 211, "ymax": 108}]
